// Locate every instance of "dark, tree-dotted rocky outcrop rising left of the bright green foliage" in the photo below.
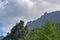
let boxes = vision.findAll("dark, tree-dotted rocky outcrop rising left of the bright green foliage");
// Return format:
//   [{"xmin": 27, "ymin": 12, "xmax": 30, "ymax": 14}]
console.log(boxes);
[{"xmin": 4, "ymin": 20, "xmax": 26, "ymax": 40}]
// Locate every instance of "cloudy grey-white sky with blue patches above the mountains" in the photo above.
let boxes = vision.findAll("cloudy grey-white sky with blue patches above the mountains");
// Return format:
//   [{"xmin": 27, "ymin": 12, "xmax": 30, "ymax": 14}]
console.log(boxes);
[{"xmin": 0, "ymin": 0, "xmax": 60, "ymax": 36}]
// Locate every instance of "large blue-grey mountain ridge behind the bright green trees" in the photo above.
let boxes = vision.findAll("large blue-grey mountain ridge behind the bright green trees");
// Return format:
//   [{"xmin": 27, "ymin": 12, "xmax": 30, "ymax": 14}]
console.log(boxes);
[{"xmin": 27, "ymin": 11, "xmax": 60, "ymax": 28}]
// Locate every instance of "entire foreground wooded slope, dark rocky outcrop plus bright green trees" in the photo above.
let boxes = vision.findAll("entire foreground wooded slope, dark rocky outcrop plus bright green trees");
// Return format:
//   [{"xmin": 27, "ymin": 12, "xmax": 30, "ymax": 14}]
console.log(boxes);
[{"xmin": 3, "ymin": 20, "xmax": 60, "ymax": 40}]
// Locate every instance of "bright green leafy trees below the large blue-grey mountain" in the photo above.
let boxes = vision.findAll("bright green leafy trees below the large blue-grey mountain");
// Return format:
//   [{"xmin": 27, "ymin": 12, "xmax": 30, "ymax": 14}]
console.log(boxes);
[{"xmin": 25, "ymin": 20, "xmax": 60, "ymax": 40}]
